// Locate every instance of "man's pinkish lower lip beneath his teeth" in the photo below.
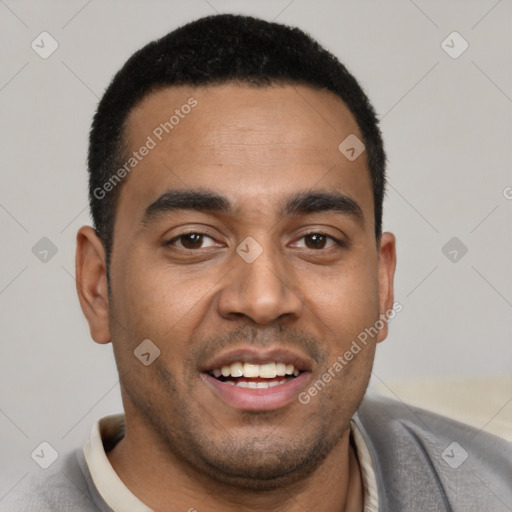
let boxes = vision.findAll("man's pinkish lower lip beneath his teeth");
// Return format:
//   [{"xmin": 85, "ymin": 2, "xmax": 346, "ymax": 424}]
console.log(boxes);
[{"xmin": 201, "ymin": 372, "xmax": 309, "ymax": 411}]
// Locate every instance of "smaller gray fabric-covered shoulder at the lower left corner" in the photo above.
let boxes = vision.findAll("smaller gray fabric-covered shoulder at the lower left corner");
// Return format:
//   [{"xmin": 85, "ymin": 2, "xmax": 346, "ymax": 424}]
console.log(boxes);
[{"xmin": 0, "ymin": 450, "xmax": 110, "ymax": 512}]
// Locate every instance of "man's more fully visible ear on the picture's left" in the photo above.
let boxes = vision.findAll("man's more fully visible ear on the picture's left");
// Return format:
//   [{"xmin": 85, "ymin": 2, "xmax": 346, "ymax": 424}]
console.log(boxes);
[{"xmin": 75, "ymin": 226, "xmax": 111, "ymax": 343}]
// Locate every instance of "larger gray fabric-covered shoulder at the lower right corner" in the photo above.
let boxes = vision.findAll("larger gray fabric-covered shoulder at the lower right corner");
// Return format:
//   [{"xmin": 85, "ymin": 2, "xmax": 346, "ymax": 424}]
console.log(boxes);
[{"xmin": 354, "ymin": 394, "xmax": 512, "ymax": 511}]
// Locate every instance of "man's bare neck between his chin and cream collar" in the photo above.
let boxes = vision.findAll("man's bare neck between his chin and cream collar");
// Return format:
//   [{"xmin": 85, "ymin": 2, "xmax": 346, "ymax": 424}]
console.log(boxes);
[{"xmin": 107, "ymin": 414, "xmax": 363, "ymax": 512}]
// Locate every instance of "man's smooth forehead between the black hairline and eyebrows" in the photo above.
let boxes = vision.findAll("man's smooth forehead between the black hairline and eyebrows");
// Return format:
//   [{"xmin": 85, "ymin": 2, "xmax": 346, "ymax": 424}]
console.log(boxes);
[{"xmin": 118, "ymin": 84, "xmax": 373, "ymax": 224}]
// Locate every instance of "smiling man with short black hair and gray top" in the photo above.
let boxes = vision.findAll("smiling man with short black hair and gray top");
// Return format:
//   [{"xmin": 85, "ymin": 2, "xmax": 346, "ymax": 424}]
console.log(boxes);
[{"xmin": 4, "ymin": 15, "xmax": 512, "ymax": 512}]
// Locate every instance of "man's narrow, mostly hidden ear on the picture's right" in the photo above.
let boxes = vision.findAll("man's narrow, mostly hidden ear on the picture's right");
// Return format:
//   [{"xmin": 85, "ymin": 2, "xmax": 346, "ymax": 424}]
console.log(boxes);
[{"xmin": 377, "ymin": 232, "xmax": 396, "ymax": 343}]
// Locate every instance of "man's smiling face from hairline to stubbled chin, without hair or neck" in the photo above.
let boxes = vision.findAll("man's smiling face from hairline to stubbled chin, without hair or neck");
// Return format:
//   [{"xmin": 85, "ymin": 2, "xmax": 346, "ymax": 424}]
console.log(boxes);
[{"xmin": 96, "ymin": 85, "xmax": 394, "ymax": 488}]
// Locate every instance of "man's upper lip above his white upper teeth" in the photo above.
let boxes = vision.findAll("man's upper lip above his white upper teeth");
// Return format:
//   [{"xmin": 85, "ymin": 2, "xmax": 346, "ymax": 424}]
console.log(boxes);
[{"xmin": 201, "ymin": 347, "xmax": 312, "ymax": 372}]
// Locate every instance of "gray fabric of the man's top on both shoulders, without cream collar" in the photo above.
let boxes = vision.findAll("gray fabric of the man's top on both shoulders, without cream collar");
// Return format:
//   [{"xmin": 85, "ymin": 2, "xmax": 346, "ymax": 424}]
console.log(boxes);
[{"xmin": 0, "ymin": 395, "xmax": 512, "ymax": 512}]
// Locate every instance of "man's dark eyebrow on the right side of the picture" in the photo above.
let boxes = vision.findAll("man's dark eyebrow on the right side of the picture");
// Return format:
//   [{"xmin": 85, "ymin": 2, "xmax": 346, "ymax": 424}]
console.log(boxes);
[{"xmin": 281, "ymin": 191, "xmax": 364, "ymax": 225}]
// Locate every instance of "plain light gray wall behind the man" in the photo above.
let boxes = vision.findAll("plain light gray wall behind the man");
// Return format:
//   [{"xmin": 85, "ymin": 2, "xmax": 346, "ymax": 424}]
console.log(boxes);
[{"xmin": 0, "ymin": 0, "xmax": 512, "ymax": 498}]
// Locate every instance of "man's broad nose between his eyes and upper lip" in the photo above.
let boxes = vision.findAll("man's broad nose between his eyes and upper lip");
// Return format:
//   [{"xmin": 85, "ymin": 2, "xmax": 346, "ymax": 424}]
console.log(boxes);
[{"xmin": 218, "ymin": 239, "xmax": 304, "ymax": 325}]
